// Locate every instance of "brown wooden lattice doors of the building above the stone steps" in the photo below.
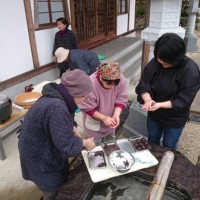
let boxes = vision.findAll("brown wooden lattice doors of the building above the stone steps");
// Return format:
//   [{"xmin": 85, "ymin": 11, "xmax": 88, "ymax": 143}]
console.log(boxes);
[{"xmin": 72, "ymin": 0, "xmax": 116, "ymax": 48}]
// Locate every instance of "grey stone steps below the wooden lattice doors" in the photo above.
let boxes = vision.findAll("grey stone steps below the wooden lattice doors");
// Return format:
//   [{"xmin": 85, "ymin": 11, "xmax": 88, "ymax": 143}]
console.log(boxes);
[{"xmin": 91, "ymin": 37, "xmax": 143, "ymax": 84}]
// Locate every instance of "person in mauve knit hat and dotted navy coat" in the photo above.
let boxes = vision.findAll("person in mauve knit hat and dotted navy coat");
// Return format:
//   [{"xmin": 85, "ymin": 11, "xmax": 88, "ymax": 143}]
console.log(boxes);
[{"xmin": 18, "ymin": 69, "xmax": 95, "ymax": 200}]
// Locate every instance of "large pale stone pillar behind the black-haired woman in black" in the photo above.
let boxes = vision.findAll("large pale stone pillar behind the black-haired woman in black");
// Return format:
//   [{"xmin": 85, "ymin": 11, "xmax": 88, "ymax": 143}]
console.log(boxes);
[{"xmin": 141, "ymin": 0, "xmax": 185, "ymax": 60}]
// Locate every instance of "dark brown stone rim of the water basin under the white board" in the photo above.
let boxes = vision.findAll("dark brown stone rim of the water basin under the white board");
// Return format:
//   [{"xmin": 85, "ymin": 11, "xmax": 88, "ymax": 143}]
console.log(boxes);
[{"xmin": 56, "ymin": 145, "xmax": 200, "ymax": 200}]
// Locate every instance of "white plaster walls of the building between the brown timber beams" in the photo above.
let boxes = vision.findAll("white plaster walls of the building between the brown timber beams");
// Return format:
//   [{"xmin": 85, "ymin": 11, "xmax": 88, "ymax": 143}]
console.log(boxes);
[{"xmin": 0, "ymin": 0, "xmax": 135, "ymax": 99}]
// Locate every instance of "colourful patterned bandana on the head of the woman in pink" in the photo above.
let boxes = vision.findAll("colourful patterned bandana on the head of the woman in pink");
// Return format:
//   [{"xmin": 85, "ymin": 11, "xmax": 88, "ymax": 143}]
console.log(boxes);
[{"xmin": 97, "ymin": 62, "xmax": 121, "ymax": 80}]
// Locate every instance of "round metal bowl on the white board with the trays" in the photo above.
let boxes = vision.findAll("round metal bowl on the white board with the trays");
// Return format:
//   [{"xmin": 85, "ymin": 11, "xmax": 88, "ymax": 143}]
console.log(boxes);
[{"xmin": 108, "ymin": 150, "xmax": 135, "ymax": 173}]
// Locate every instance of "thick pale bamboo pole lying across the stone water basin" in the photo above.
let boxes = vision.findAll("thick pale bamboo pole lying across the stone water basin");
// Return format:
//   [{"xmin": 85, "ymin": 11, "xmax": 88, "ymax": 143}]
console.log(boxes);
[{"xmin": 146, "ymin": 151, "xmax": 174, "ymax": 200}]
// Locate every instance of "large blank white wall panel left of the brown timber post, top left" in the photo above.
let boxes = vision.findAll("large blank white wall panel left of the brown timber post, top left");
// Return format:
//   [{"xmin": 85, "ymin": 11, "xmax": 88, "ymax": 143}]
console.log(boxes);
[{"xmin": 0, "ymin": 0, "xmax": 33, "ymax": 82}]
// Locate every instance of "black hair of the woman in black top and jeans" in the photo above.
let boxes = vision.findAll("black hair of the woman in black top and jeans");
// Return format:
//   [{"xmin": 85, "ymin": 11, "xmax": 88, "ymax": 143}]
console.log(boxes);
[{"xmin": 154, "ymin": 33, "xmax": 186, "ymax": 64}]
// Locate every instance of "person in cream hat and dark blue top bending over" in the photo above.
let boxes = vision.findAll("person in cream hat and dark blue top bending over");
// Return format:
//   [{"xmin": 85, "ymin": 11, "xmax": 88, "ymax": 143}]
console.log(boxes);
[{"xmin": 55, "ymin": 47, "xmax": 100, "ymax": 75}]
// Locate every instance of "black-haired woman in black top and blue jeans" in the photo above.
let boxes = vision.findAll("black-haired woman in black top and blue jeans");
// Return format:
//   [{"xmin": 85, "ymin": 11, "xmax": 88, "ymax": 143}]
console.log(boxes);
[{"xmin": 136, "ymin": 33, "xmax": 200, "ymax": 149}]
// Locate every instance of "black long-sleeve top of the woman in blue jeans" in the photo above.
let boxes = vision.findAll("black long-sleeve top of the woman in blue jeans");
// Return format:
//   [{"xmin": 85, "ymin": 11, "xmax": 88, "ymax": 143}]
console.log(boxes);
[{"xmin": 136, "ymin": 56, "xmax": 200, "ymax": 128}]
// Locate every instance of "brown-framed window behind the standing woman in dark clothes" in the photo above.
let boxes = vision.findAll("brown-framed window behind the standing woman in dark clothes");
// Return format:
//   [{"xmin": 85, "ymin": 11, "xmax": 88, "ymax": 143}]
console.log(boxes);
[{"xmin": 35, "ymin": 0, "xmax": 66, "ymax": 28}]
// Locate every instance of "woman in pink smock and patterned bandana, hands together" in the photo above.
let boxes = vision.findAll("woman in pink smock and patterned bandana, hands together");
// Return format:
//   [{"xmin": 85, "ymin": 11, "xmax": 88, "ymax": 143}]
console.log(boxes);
[{"xmin": 79, "ymin": 62, "xmax": 128, "ymax": 145}]
